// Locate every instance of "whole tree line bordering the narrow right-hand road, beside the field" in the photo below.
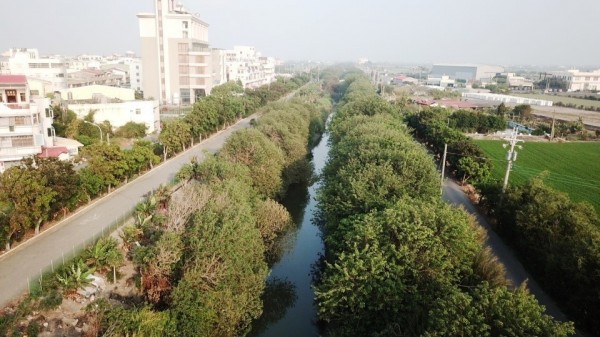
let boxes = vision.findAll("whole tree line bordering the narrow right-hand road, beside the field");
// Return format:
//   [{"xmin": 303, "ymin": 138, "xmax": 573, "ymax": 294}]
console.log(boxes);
[{"xmin": 406, "ymin": 98, "xmax": 600, "ymax": 335}]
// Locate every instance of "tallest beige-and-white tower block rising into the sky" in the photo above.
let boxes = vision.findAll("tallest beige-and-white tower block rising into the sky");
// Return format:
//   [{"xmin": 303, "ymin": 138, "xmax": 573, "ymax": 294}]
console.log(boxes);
[{"xmin": 137, "ymin": 0, "xmax": 213, "ymax": 104}]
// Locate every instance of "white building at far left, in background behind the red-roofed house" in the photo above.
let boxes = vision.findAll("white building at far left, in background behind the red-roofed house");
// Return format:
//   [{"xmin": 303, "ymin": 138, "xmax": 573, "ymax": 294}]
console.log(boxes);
[{"xmin": 0, "ymin": 48, "xmax": 67, "ymax": 92}]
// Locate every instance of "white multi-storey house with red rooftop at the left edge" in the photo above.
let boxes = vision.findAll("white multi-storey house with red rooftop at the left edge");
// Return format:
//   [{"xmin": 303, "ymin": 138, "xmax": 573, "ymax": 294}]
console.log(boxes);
[{"xmin": 0, "ymin": 75, "xmax": 55, "ymax": 172}]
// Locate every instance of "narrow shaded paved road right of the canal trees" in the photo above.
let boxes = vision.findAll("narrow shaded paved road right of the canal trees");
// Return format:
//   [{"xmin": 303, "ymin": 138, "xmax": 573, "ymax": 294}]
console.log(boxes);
[{"xmin": 443, "ymin": 179, "xmax": 568, "ymax": 321}]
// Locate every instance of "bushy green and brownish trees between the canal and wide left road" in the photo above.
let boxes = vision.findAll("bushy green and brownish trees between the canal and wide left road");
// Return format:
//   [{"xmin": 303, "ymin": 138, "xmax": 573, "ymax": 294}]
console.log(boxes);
[{"xmin": 0, "ymin": 81, "xmax": 331, "ymax": 336}]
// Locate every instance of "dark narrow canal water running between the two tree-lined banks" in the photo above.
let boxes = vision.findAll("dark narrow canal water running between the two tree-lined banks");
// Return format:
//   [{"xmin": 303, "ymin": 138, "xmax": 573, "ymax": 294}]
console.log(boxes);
[{"xmin": 250, "ymin": 124, "xmax": 329, "ymax": 337}]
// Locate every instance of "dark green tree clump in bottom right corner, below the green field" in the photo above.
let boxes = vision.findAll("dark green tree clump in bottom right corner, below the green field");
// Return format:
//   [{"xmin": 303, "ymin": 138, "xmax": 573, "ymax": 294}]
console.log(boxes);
[{"xmin": 480, "ymin": 178, "xmax": 600, "ymax": 334}]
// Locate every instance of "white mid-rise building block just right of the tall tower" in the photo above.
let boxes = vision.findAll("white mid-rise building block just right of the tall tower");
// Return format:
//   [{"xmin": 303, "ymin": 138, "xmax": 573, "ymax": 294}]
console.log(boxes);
[{"xmin": 224, "ymin": 46, "xmax": 275, "ymax": 88}]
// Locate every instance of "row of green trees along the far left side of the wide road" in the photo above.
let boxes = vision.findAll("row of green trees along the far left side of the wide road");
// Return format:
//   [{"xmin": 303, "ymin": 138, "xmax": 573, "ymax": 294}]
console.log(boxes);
[{"xmin": 0, "ymin": 75, "xmax": 308, "ymax": 250}]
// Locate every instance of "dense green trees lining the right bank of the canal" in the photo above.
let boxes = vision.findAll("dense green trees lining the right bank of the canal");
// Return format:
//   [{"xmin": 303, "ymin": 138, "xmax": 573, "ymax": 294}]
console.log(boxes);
[{"xmin": 315, "ymin": 69, "xmax": 573, "ymax": 336}]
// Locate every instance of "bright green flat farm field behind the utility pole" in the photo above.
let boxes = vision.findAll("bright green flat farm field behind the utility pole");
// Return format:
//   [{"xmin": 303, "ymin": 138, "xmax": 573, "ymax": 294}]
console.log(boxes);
[{"xmin": 475, "ymin": 140, "xmax": 600, "ymax": 214}]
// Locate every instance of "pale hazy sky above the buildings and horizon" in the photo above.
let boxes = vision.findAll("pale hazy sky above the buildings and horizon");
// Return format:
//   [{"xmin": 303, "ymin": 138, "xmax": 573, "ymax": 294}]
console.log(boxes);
[{"xmin": 0, "ymin": 0, "xmax": 600, "ymax": 66}]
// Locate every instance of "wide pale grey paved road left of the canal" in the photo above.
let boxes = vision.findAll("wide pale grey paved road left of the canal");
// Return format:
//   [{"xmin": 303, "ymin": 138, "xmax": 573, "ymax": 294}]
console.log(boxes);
[{"xmin": 0, "ymin": 116, "xmax": 253, "ymax": 308}]
